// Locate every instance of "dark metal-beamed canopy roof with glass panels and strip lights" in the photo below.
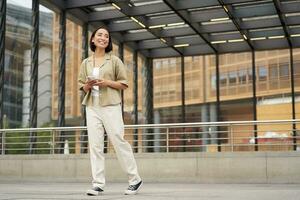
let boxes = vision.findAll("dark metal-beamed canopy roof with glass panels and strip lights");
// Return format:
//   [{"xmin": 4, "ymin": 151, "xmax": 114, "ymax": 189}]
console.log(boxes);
[{"xmin": 41, "ymin": 0, "xmax": 300, "ymax": 58}]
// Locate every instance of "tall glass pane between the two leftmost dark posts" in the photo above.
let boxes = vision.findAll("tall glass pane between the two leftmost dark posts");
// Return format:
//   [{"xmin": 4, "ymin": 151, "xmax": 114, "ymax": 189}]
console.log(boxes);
[{"xmin": 3, "ymin": 0, "xmax": 32, "ymax": 128}]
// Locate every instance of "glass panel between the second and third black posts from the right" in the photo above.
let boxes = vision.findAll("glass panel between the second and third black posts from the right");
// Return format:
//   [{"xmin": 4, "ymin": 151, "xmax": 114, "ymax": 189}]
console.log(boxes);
[{"xmin": 218, "ymin": 52, "xmax": 254, "ymax": 151}]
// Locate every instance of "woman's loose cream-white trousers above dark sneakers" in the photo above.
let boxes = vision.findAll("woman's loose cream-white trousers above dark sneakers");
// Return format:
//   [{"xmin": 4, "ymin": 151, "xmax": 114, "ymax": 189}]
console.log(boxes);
[{"xmin": 86, "ymin": 101, "xmax": 141, "ymax": 189}]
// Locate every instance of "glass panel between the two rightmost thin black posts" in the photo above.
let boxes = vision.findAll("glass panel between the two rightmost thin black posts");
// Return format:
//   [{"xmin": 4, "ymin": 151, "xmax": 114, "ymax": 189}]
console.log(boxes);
[{"xmin": 255, "ymin": 49, "xmax": 292, "ymax": 150}]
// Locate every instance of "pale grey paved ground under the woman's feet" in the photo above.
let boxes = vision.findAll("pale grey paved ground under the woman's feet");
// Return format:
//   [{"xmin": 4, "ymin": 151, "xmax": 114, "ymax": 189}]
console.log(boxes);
[{"xmin": 0, "ymin": 181, "xmax": 300, "ymax": 200}]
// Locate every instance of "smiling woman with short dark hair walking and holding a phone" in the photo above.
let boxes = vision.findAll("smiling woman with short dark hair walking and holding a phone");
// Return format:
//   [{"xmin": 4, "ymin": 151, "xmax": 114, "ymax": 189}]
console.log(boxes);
[{"xmin": 78, "ymin": 27, "xmax": 143, "ymax": 195}]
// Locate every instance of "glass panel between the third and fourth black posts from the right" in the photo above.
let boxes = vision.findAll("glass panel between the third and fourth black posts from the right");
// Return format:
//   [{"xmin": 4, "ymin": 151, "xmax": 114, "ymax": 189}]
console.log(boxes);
[{"xmin": 183, "ymin": 55, "xmax": 217, "ymax": 151}]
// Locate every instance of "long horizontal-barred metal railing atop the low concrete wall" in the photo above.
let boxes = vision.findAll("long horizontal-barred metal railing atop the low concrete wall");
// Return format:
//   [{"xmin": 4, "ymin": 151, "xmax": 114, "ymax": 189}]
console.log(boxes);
[{"xmin": 0, "ymin": 120, "xmax": 300, "ymax": 155}]
